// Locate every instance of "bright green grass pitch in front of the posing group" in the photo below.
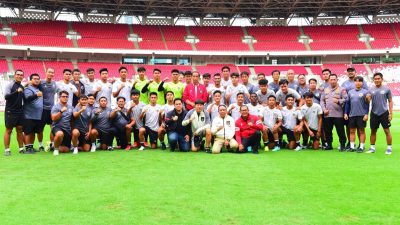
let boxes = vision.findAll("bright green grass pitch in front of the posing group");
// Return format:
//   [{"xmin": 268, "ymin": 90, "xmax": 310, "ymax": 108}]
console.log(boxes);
[{"xmin": 0, "ymin": 113, "xmax": 400, "ymax": 224}]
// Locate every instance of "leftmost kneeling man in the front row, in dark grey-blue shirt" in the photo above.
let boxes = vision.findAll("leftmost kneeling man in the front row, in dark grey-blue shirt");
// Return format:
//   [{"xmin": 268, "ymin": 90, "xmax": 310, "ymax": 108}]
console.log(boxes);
[{"xmin": 51, "ymin": 91, "xmax": 74, "ymax": 155}]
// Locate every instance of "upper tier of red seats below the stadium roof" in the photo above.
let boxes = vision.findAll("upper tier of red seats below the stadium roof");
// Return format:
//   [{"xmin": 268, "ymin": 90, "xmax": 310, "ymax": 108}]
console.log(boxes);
[{"xmin": 0, "ymin": 21, "xmax": 400, "ymax": 52}]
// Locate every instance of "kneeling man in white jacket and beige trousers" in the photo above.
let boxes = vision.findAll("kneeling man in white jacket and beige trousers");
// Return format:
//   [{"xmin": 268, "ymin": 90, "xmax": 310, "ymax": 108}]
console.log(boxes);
[{"xmin": 211, "ymin": 105, "xmax": 238, "ymax": 154}]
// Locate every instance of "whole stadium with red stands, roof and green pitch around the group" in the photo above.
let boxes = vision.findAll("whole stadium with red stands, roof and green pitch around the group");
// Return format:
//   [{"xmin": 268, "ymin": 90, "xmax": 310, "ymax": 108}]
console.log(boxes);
[{"xmin": 0, "ymin": 0, "xmax": 400, "ymax": 224}]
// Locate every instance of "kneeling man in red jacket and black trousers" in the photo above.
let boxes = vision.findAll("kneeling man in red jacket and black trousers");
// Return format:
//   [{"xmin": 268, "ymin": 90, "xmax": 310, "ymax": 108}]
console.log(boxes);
[{"xmin": 235, "ymin": 105, "xmax": 263, "ymax": 154}]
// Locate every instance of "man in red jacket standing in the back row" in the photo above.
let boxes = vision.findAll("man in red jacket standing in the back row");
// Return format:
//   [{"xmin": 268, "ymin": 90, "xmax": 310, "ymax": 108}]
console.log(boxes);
[{"xmin": 182, "ymin": 71, "xmax": 208, "ymax": 110}]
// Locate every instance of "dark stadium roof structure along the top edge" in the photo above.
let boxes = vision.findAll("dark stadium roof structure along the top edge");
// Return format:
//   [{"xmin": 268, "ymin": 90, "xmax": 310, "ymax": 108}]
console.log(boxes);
[{"xmin": 0, "ymin": 0, "xmax": 400, "ymax": 18}]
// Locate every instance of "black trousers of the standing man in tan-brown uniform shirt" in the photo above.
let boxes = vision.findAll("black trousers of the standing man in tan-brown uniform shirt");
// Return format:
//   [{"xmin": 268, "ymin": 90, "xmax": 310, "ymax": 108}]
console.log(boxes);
[{"xmin": 323, "ymin": 117, "xmax": 346, "ymax": 146}]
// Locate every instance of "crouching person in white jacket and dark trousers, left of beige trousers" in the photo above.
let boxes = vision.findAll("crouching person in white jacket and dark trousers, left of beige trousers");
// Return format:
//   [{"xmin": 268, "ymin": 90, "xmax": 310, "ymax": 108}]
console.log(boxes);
[{"xmin": 182, "ymin": 99, "xmax": 211, "ymax": 153}]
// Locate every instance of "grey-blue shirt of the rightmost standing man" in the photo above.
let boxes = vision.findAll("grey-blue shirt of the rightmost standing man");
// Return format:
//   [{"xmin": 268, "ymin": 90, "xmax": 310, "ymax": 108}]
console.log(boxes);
[{"xmin": 370, "ymin": 85, "xmax": 392, "ymax": 116}]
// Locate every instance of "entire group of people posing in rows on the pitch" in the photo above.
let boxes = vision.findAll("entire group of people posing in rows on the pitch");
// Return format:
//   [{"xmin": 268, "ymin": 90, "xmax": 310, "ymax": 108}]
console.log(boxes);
[{"xmin": 4, "ymin": 66, "xmax": 393, "ymax": 156}]
